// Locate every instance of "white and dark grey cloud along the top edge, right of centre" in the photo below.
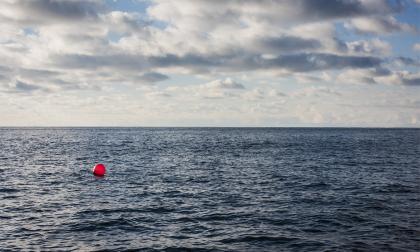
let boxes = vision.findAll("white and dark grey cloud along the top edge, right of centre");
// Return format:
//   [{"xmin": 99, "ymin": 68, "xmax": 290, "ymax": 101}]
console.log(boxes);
[{"xmin": 148, "ymin": 0, "xmax": 400, "ymax": 30}]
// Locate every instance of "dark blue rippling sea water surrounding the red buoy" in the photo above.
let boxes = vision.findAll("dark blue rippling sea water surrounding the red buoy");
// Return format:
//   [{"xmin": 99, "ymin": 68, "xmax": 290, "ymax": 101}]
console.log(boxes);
[{"xmin": 0, "ymin": 128, "xmax": 420, "ymax": 251}]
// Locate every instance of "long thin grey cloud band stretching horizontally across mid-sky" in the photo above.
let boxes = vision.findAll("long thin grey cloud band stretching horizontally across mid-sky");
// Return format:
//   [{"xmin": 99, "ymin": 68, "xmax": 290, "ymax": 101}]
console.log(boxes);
[{"xmin": 52, "ymin": 50, "xmax": 382, "ymax": 72}]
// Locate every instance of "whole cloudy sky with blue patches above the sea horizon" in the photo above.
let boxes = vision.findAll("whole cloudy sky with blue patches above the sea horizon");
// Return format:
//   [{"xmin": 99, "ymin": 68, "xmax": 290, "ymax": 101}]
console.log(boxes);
[{"xmin": 0, "ymin": 0, "xmax": 420, "ymax": 127}]
